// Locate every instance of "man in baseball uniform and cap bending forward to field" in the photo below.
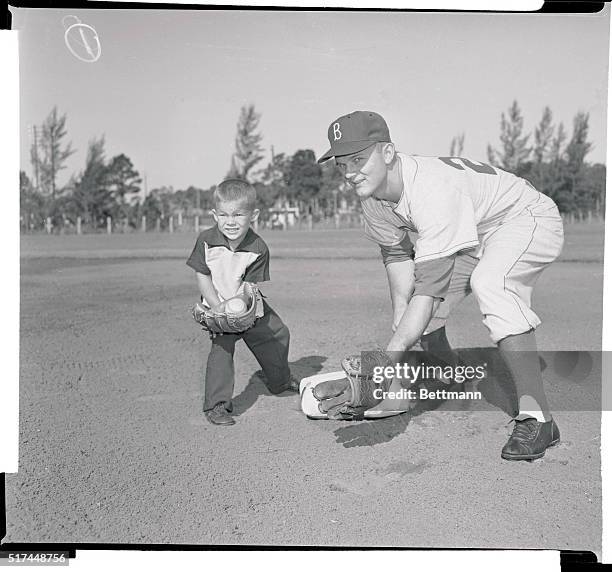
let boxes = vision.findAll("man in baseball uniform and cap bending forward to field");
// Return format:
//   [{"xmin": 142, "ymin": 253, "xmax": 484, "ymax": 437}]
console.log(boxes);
[{"xmin": 319, "ymin": 111, "xmax": 563, "ymax": 460}]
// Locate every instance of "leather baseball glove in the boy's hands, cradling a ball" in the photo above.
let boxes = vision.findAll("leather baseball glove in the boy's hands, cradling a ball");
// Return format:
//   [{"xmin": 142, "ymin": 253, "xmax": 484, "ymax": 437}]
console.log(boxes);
[{"xmin": 191, "ymin": 282, "xmax": 260, "ymax": 337}]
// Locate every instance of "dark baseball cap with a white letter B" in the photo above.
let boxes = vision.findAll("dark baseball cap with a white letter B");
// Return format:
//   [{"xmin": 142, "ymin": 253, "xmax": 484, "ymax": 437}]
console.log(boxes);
[{"xmin": 317, "ymin": 111, "xmax": 391, "ymax": 163}]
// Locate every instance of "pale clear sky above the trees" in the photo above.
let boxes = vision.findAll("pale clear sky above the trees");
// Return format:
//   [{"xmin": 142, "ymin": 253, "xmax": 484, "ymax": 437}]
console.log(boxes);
[{"xmin": 13, "ymin": 5, "xmax": 609, "ymax": 189}]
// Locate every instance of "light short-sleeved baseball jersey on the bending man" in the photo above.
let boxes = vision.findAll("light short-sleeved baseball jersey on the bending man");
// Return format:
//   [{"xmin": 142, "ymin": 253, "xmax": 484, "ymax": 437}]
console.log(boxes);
[{"xmin": 362, "ymin": 153, "xmax": 554, "ymax": 263}]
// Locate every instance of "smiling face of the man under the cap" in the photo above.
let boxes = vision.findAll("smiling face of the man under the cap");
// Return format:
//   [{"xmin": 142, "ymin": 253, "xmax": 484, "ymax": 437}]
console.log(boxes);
[{"xmin": 336, "ymin": 143, "xmax": 387, "ymax": 199}]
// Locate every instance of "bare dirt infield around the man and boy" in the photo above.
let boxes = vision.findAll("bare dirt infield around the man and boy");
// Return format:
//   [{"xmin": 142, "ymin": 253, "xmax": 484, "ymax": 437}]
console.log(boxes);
[{"xmin": 5, "ymin": 225, "xmax": 603, "ymax": 553}]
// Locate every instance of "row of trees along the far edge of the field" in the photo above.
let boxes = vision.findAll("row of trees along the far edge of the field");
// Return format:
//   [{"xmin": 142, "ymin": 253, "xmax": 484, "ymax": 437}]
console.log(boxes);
[{"xmin": 20, "ymin": 101, "xmax": 606, "ymax": 230}]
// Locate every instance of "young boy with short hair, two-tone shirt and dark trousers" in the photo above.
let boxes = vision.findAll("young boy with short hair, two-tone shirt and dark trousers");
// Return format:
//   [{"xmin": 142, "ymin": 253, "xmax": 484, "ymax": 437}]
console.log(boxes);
[{"xmin": 187, "ymin": 179, "xmax": 299, "ymax": 425}]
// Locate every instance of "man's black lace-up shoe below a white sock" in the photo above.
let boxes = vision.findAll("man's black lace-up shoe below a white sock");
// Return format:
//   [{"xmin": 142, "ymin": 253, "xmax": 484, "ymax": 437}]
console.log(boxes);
[{"xmin": 502, "ymin": 417, "xmax": 561, "ymax": 461}]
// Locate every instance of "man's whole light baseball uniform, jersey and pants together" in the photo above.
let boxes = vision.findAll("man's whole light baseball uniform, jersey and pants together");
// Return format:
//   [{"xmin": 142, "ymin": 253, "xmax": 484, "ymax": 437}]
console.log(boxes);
[{"xmin": 362, "ymin": 153, "xmax": 563, "ymax": 343}]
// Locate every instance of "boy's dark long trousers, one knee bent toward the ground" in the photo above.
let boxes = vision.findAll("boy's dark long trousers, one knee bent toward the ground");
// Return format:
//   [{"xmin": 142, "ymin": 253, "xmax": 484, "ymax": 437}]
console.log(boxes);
[{"xmin": 201, "ymin": 300, "xmax": 291, "ymax": 411}]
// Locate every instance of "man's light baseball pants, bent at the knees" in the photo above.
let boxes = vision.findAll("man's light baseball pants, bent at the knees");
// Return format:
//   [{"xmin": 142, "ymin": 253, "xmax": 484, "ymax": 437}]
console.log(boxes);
[{"xmin": 426, "ymin": 200, "xmax": 563, "ymax": 343}]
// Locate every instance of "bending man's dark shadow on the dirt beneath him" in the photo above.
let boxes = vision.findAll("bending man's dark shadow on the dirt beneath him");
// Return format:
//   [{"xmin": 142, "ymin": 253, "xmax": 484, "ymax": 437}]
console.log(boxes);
[{"xmin": 334, "ymin": 347, "xmax": 546, "ymax": 447}]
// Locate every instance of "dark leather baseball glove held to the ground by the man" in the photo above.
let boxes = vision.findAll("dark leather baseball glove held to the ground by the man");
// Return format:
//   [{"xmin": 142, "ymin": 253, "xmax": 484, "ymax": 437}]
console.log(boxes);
[{"xmin": 312, "ymin": 351, "xmax": 394, "ymax": 420}]
